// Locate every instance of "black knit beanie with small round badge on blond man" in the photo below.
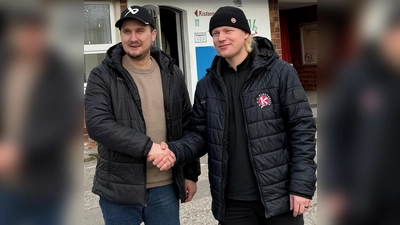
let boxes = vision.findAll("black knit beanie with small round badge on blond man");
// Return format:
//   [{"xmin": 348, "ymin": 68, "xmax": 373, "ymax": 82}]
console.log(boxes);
[{"xmin": 209, "ymin": 6, "xmax": 251, "ymax": 36}]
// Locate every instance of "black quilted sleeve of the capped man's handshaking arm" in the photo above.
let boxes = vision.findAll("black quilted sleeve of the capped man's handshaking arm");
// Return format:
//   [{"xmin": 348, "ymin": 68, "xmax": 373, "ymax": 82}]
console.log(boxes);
[{"xmin": 85, "ymin": 67, "xmax": 153, "ymax": 158}]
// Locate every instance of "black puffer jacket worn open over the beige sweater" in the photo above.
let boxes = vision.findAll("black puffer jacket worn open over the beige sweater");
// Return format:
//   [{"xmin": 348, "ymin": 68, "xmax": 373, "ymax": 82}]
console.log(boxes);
[{"xmin": 85, "ymin": 44, "xmax": 200, "ymax": 205}]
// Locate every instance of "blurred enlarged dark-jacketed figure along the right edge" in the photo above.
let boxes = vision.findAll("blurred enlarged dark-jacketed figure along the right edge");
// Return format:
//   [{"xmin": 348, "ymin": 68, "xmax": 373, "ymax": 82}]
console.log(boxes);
[{"xmin": 320, "ymin": 1, "xmax": 400, "ymax": 225}]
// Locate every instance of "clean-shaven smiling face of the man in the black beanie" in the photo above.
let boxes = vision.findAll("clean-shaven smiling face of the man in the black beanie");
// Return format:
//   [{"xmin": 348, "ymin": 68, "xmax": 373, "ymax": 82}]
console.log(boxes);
[{"xmin": 211, "ymin": 26, "xmax": 249, "ymax": 60}]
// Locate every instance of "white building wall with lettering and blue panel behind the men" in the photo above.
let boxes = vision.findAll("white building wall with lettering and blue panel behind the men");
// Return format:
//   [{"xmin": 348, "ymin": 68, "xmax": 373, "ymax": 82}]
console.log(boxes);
[{"xmin": 127, "ymin": 0, "xmax": 271, "ymax": 100}]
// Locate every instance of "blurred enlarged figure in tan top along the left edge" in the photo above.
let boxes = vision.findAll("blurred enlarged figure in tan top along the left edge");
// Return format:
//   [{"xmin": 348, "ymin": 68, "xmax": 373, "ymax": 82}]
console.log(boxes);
[{"xmin": 0, "ymin": 4, "xmax": 81, "ymax": 225}]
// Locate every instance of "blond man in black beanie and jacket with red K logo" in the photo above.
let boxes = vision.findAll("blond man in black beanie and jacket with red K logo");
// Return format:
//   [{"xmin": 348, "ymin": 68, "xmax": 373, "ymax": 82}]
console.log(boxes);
[{"xmin": 149, "ymin": 6, "xmax": 316, "ymax": 225}]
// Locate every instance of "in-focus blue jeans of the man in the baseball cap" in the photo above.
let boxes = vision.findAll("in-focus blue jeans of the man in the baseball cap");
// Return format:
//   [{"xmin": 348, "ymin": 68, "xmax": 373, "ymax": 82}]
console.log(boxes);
[{"xmin": 100, "ymin": 184, "xmax": 180, "ymax": 225}]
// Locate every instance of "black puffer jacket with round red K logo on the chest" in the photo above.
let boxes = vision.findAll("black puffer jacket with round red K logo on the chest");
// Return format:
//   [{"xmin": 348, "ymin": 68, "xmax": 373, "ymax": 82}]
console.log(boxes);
[{"xmin": 169, "ymin": 37, "xmax": 316, "ymax": 221}]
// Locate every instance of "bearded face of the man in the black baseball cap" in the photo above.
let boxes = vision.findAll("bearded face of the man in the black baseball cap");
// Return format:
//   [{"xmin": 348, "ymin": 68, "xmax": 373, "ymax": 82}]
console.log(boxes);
[{"xmin": 120, "ymin": 19, "xmax": 157, "ymax": 60}]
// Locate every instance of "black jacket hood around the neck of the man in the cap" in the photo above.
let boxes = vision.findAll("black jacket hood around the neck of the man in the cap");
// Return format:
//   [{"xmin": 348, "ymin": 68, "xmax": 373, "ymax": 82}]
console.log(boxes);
[{"xmin": 103, "ymin": 43, "xmax": 175, "ymax": 71}]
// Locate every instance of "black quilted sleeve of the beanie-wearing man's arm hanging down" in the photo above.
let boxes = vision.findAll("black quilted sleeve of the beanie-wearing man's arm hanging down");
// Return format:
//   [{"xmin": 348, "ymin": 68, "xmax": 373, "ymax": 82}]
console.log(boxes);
[{"xmin": 279, "ymin": 64, "xmax": 317, "ymax": 198}]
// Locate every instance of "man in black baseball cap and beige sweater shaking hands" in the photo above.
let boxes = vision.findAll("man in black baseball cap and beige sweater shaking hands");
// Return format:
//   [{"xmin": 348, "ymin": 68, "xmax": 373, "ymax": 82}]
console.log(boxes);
[{"xmin": 85, "ymin": 6, "xmax": 200, "ymax": 225}]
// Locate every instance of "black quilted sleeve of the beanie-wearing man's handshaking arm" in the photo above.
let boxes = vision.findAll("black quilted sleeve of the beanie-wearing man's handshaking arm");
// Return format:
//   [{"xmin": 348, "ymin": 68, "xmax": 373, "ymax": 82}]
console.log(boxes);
[{"xmin": 168, "ymin": 82, "xmax": 207, "ymax": 166}]
